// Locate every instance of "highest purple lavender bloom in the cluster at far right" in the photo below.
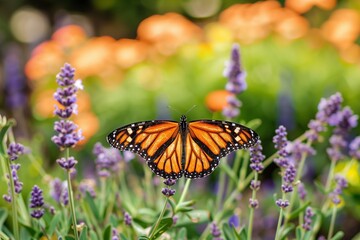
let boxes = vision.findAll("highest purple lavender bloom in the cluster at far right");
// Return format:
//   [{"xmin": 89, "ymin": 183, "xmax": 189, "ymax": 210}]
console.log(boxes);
[{"xmin": 316, "ymin": 93, "xmax": 343, "ymax": 125}]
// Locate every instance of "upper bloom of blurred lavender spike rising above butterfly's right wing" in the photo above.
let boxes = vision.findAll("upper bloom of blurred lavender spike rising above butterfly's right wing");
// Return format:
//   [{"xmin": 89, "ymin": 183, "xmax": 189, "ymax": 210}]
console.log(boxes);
[{"xmin": 224, "ymin": 44, "xmax": 247, "ymax": 94}]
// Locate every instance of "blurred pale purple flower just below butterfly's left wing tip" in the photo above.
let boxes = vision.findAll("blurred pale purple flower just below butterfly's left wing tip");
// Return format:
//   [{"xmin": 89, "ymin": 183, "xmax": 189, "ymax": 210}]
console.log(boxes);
[{"xmin": 93, "ymin": 143, "xmax": 122, "ymax": 177}]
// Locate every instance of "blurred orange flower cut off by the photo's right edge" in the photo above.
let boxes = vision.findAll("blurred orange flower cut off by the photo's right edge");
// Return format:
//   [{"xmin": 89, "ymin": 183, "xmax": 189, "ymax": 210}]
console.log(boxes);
[{"xmin": 321, "ymin": 9, "xmax": 360, "ymax": 49}]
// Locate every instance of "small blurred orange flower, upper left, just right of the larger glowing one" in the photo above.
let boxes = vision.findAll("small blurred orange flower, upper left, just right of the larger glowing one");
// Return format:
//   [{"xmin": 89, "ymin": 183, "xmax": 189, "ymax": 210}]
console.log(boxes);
[{"xmin": 114, "ymin": 39, "xmax": 148, "ymax": 68}]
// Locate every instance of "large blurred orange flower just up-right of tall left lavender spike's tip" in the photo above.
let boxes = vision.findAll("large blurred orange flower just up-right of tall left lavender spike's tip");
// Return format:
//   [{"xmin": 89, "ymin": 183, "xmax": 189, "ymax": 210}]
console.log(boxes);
[{"xmin": 69, "ymin": 36, "xmax": 115, "ymax": 78}]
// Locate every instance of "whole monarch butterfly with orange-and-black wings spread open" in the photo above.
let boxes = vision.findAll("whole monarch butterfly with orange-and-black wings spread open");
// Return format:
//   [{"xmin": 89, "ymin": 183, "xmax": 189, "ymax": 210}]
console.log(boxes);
[{"xmin": 107, "ymin": 115, "xmax": 259, "ymax": 179}]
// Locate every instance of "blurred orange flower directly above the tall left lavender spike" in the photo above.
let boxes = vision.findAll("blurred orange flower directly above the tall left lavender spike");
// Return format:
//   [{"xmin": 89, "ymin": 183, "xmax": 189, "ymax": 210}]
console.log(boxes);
[{"xmin": 52, "ymin": 25, "xmax": 87, "ymax": 48}]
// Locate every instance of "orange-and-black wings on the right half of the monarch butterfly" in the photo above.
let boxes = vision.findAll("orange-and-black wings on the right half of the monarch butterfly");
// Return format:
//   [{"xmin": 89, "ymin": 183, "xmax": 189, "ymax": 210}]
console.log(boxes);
[{"xmin": 184, "ymin": 120, "xmax": 259, "ymax": 178}]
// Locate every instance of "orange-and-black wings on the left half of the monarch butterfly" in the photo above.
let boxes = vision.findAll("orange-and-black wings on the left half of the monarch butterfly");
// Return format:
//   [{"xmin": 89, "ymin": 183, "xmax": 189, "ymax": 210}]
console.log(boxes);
[{"xmin": 107, "ymin": 120, "xmax": 183, "ymax": 179}]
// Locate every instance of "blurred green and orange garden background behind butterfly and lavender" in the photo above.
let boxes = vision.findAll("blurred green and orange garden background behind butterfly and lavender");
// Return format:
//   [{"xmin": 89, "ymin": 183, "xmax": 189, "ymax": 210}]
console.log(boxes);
[{"xmin": 0, "ymin": 0, "xmax": 360, "ymax": 239}]
